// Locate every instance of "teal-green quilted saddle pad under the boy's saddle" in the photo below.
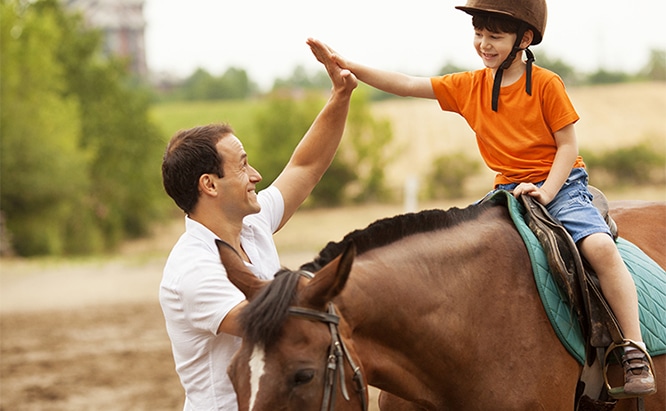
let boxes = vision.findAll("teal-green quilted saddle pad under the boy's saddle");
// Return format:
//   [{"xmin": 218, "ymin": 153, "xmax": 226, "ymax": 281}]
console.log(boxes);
[{"xmin": 492, "ymin": 191, "xmax": 666, "ymax": 364}]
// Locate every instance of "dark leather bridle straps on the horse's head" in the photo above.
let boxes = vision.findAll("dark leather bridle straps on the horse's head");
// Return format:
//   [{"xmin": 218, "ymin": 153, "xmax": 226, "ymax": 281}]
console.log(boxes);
[{"xmin": 289, "ymin": 270, "xmax": 368, "ymax": 411}]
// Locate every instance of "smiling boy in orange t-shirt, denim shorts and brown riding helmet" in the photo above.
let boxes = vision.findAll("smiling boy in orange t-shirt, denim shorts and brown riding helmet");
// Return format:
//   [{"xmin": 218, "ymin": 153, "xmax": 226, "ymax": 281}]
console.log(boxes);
[{"xmin": 306, "ymin": 0, "xmax": 656, "ymax": 396}]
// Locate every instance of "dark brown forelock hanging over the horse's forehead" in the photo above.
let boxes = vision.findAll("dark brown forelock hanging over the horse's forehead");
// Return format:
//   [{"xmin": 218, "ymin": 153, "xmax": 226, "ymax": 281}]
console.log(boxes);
[{"xmin": 239, "ymin": 269, "xmax": 301, "ymax": 347}]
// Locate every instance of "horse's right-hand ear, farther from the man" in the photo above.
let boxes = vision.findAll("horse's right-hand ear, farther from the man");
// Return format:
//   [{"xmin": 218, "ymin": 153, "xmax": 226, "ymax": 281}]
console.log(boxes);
[{"xmin": 299, "ymin": 242, "xmax": 356, "ymax": 309}]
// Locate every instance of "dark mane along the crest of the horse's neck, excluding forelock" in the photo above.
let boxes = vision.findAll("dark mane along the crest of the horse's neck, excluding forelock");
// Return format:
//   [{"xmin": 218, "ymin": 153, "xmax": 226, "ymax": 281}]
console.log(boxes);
[{"xmin": 300, "ymin": 202, "xmax": 495, "ymax": 272}]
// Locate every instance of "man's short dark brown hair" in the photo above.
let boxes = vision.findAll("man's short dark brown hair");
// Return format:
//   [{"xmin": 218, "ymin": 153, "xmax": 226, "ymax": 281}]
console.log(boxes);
[{"xmin": 162, "ymin": 124, "xmax": 234, "ymax": 214}]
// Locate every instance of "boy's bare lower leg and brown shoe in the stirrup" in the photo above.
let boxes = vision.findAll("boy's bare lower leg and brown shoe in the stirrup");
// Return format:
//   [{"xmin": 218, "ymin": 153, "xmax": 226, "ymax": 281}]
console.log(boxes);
[{"xmin": 579, "ymin": 233, "xmax": 656, "ymax": 396}]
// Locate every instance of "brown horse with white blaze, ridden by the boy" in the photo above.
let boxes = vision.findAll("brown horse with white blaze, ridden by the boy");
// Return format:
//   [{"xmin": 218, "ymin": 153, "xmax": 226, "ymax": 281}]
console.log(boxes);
[{"xmin": 219, "ymin": 198, "xmax": 666, "ymax": 411}]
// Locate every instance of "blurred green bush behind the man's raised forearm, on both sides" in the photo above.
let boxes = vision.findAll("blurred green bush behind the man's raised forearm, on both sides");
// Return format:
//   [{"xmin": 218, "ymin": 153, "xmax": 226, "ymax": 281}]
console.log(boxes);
[{"xmin": 245, "ymin": 87, "xmax": 393, "ymax": 207}]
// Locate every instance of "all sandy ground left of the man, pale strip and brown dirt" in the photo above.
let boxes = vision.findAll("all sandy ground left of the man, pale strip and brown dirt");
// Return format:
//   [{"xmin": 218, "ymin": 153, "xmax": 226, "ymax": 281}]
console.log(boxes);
[{"xmin": 0, "ymin": 249, "xmax": 376, "ymax": 411}]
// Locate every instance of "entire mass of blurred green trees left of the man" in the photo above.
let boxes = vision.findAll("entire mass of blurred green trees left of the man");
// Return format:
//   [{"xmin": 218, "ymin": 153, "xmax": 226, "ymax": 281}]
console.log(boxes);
[{"xmin": 0, "ymin": 0, "xmax": 163, "ymax": 255}]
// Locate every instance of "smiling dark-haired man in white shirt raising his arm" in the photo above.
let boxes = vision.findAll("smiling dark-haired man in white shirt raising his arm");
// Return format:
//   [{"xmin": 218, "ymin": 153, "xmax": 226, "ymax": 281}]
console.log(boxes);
[{"xmin": 160, "ymin": 40, "xmax": 357, "ymax": 410}]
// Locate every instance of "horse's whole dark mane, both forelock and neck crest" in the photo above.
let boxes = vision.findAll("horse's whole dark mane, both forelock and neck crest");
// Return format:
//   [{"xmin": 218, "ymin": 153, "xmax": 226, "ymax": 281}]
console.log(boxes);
[{"xmin": 239, "ymin": 202, "xmax": 493, "ymax": 347}]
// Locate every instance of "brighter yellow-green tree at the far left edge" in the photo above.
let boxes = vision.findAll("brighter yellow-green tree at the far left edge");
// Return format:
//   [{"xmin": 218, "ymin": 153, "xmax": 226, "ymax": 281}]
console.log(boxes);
[{"xmin": 0, "ymin": 1, "xmax": 93, "ymax": 255}]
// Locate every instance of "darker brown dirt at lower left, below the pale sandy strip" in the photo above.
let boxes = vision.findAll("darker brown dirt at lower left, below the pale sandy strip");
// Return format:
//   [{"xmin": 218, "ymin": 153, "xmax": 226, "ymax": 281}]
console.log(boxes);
[{"xmin": 0, "ymin": 302, "xmax": 183, "ymax": 411}]
